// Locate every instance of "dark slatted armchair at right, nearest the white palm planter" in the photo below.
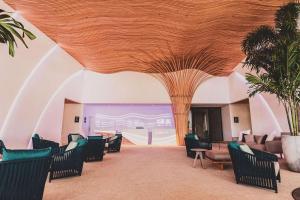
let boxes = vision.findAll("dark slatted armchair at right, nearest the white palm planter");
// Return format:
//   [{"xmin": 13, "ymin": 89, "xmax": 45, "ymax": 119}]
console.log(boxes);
[{"xmin": 228, "ymin": 143, "xmax": 281, "ymax": 193}]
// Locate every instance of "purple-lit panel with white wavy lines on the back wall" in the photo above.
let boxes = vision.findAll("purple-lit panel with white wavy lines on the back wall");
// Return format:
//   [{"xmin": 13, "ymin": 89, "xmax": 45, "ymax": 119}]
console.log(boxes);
[{"xmin": 83, "ymin": 104, "xmax": 174, "ymax": 134}]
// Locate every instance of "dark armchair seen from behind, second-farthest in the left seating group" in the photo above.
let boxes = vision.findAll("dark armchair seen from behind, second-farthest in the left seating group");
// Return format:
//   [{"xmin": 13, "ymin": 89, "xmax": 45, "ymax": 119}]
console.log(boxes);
[{"xmin": 85, "ymin": 136, "xmax": 106, "ymax": 162}]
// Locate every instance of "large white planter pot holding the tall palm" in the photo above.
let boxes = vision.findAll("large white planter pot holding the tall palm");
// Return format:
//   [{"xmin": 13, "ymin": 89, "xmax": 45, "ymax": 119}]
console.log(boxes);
[{"xmin": 281, "ymin": 135, "xmax": 300, "ymax": 172}]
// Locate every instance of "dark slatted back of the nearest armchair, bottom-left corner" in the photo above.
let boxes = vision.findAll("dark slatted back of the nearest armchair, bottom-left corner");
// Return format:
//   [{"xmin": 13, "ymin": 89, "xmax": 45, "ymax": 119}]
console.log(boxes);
[{"xmin": 0, "ymin": 152, "xmax": 51, "ymax": 200}]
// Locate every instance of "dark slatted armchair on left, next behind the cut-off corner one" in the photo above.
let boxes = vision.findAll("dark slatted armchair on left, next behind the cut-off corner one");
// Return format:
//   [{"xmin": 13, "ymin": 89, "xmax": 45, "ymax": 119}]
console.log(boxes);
[{"xmin": 49, "ymin": 139, "xmax": 87, "ymax": 182}]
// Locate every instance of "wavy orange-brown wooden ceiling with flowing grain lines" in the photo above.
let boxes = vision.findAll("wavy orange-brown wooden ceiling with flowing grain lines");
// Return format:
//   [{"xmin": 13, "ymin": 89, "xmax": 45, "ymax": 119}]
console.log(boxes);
[{"xmin": 5, "ymin": 0, "xmax": 286, "ymax": 75}]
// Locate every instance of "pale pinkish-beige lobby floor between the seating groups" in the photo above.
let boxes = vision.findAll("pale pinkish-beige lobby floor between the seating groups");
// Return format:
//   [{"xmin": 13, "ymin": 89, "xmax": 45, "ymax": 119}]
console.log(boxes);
[{"xmin": 44, "ymin": 146, "xmax": 300, "ymax": 200}]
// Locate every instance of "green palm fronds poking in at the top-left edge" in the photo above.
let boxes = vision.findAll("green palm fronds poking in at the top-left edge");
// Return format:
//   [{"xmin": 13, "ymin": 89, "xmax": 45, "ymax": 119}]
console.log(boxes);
[{"xmin": 0, "ymin": 9, "xmax": 36, "ymax": 56}]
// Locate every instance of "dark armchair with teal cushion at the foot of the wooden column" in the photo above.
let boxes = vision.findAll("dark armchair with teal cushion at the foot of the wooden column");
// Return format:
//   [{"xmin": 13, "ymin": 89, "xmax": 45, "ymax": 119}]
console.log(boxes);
[{"xmin": 184, "ymin": 133, "xmax": 212, "ymax": 158}]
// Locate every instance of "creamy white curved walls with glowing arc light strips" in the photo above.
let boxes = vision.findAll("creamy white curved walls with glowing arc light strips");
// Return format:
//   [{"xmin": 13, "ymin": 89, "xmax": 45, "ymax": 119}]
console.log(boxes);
[{"xmin": 0, "ymin": 1, "xmax": 287, "ymax": 148}]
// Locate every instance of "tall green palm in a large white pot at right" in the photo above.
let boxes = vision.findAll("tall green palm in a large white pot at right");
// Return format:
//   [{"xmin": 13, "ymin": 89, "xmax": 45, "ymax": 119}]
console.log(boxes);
[{"xmin": 242, "ymin": 3, "xmax": 300, "ymax": 172}]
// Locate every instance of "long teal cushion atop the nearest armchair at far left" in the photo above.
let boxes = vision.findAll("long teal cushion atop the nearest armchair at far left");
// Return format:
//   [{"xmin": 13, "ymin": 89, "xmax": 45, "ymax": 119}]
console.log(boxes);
[{"xmin": 2, "ymin": 147, "xmax": 52, "ymax": 161}]
